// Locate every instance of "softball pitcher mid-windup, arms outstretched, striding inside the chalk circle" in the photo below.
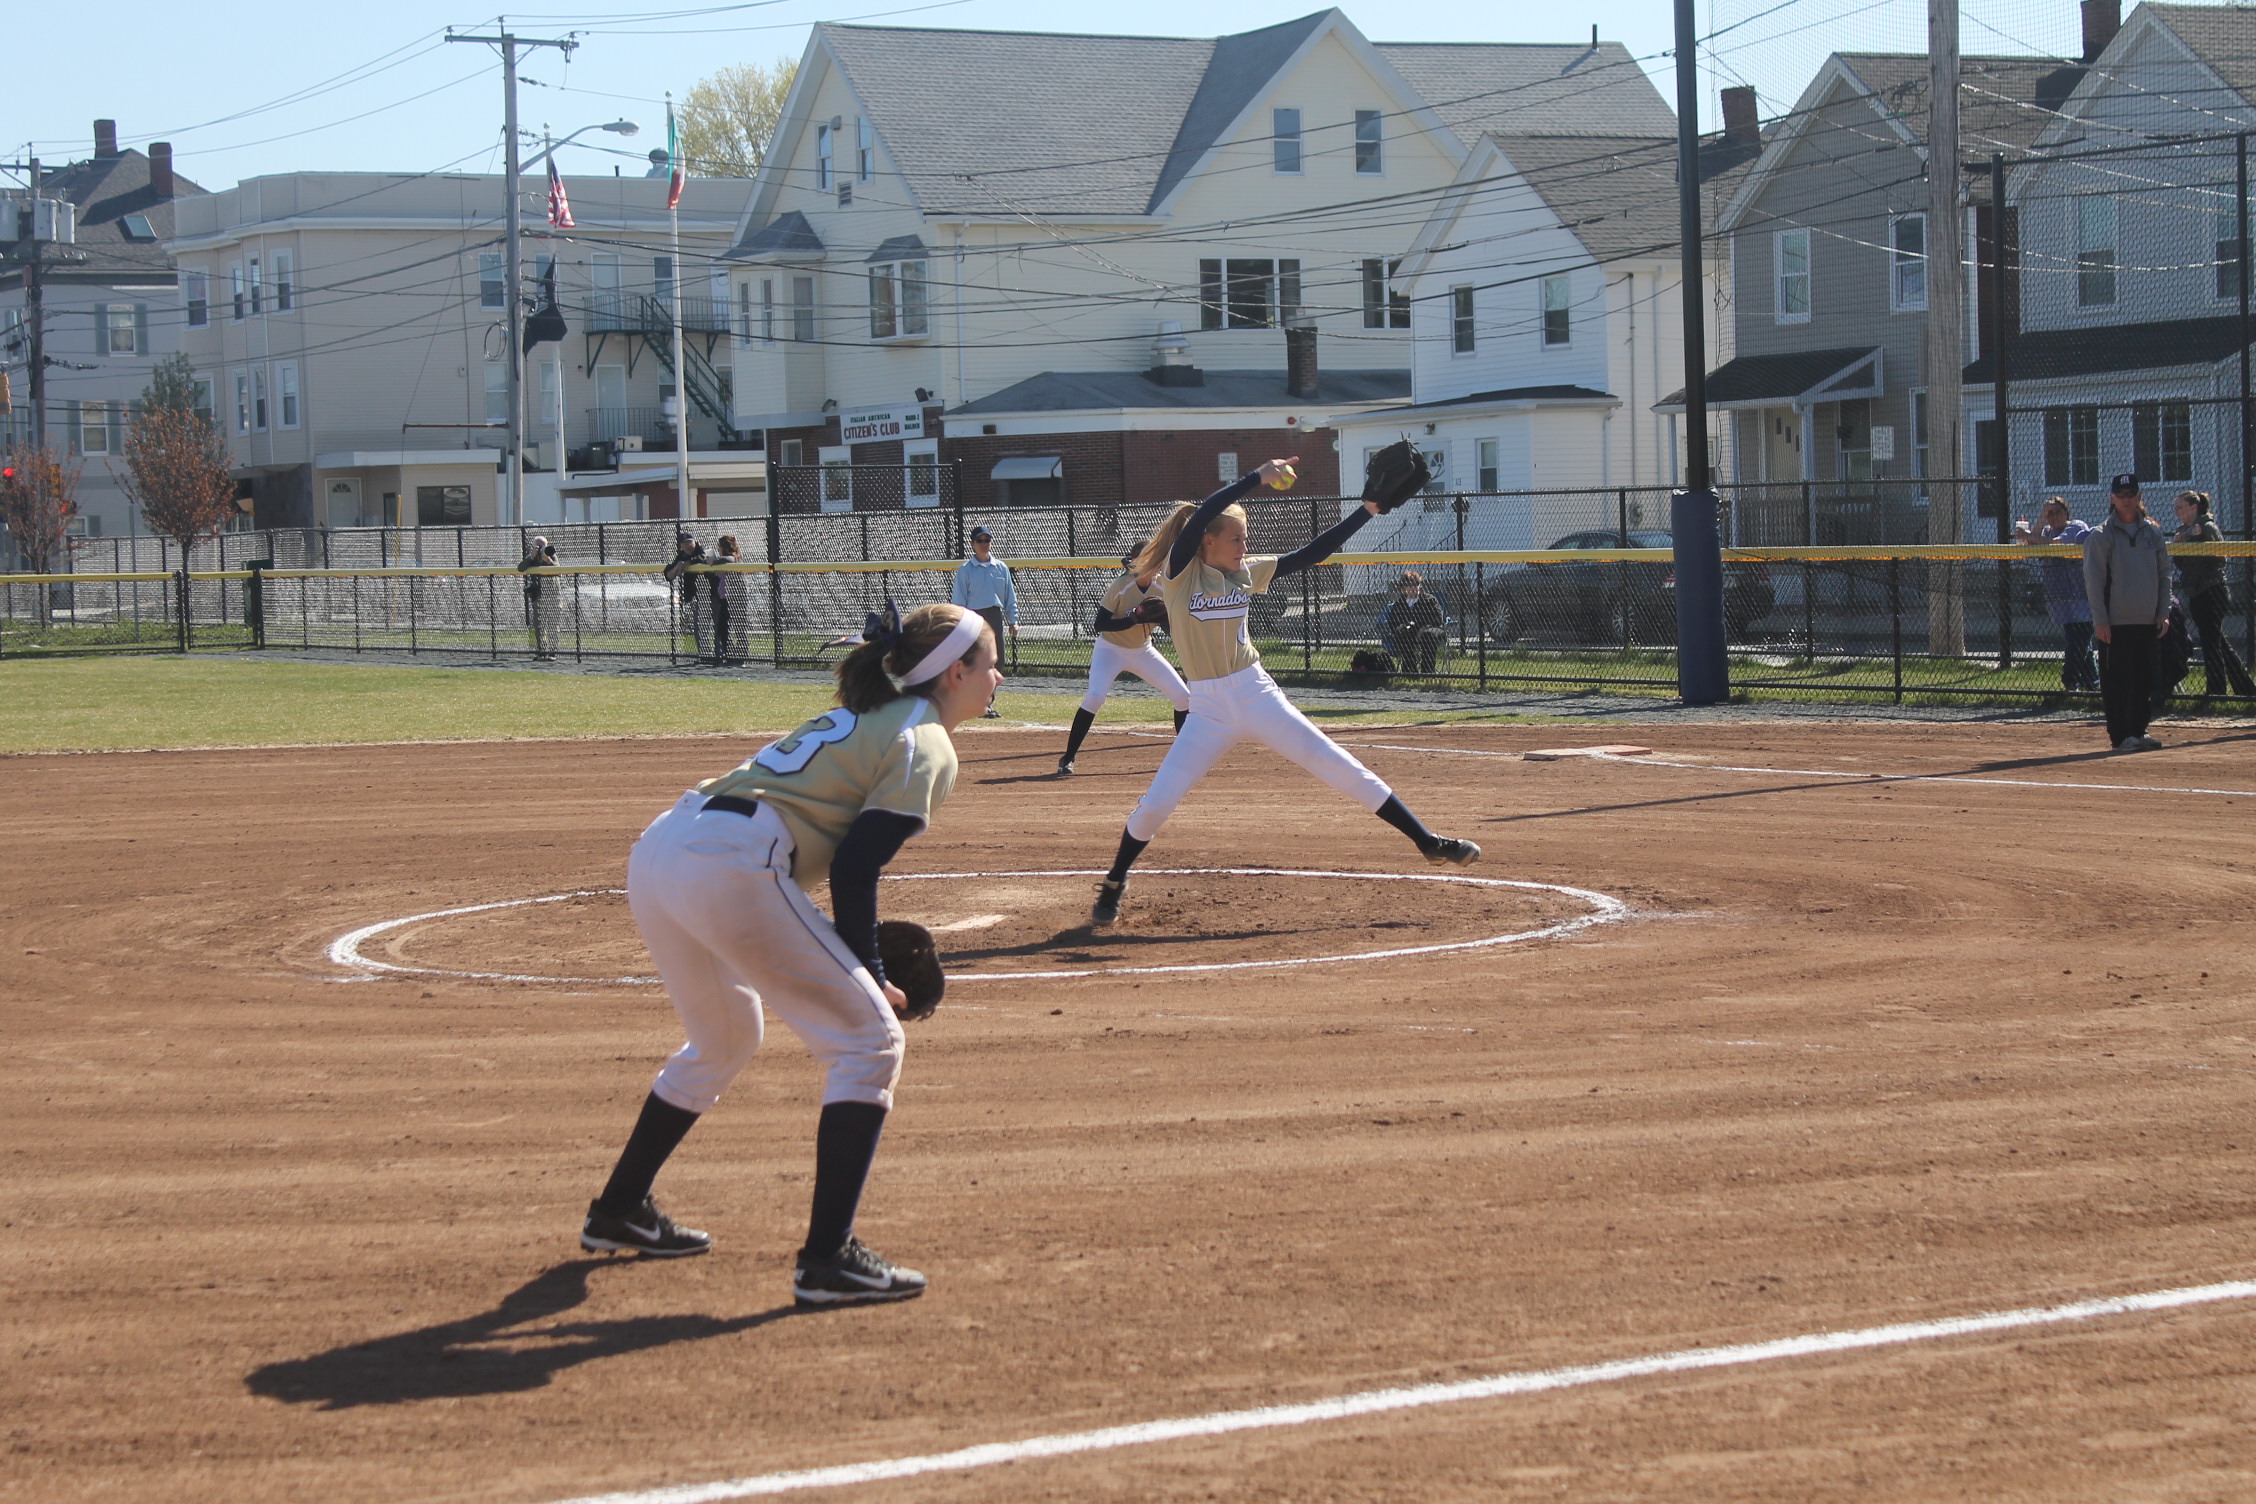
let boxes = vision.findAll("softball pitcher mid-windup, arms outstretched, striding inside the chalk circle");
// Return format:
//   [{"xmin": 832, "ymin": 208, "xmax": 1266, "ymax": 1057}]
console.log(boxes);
[{"xmin": 1090, "ymin": 442, "xmax": 1480, "ymax": 927}]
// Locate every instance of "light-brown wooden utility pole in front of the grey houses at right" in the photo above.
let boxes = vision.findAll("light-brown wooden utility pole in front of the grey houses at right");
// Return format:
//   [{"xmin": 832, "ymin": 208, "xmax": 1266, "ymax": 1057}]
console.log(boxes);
[{"xmin": 1927, "ymin": 0, "xmax": 1967, "ymax": 658}]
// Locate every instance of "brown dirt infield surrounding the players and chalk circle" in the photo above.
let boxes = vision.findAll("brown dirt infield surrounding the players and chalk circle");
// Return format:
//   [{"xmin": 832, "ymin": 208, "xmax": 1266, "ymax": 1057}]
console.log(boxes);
[{"xmin": 0, "ymin": 724, "xmax": 2256, "ymax": 1504}]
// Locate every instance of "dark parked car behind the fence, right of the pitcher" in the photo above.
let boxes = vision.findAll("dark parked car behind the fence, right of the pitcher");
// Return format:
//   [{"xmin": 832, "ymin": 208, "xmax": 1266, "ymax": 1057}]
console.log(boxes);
[{"xmin": 1480, "ymin": 528, "xmax": 1775, "ymax": 643}]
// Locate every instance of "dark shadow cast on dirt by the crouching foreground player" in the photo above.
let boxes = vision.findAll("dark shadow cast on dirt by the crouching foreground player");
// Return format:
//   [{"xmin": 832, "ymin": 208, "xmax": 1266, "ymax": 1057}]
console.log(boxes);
[{"xmin": 244, "ymin": 1258, "xmax": 812, "ymax": 1409}]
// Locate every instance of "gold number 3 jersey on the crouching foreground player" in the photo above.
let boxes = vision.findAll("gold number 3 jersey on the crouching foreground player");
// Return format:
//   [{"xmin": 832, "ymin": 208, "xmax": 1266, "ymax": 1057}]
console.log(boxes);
[{"xmin": 697, "ymin": 695, "xmax": 957, "ymax": 886}]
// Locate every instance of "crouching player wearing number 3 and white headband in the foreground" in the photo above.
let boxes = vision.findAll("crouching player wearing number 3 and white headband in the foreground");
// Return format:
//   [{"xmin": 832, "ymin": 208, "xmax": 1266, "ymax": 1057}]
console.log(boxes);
[{"xmin": 580, "ymin": 602, "xmax": 1002, "ymax": 1306}]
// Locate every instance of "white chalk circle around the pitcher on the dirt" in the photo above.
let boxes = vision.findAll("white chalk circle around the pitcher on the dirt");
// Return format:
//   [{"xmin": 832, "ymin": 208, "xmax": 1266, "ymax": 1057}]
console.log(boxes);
[{"xmin": 329, "ymin": 866, "xmax": 1629, "ymax": 988}]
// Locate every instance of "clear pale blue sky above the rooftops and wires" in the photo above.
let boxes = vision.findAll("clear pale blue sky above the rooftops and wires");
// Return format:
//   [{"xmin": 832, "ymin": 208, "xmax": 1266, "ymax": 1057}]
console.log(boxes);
[{"xmin": 0, "ymin": 0, "xmax": 2075, "ymax": 187}]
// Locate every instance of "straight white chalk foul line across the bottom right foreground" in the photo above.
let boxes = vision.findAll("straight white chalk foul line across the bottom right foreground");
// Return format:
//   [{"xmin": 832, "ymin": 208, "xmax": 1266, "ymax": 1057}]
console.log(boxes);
[{"xmin": 545, "ymin": 1281, "xmax": 2256, "ymax": 1504}]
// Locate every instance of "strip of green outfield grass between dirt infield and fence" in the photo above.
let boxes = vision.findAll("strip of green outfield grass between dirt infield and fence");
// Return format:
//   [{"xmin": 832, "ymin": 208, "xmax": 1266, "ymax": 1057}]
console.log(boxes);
[{"xmin": 0, "ymin": 654, "xmax": 1588, "ymax": 753}]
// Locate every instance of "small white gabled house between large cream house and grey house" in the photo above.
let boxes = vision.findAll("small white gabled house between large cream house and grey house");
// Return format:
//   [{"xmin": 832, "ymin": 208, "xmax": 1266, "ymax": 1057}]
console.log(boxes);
[{"xmin": 1329, "ymin": 135, "xmax": 1751, "ymax": 548}]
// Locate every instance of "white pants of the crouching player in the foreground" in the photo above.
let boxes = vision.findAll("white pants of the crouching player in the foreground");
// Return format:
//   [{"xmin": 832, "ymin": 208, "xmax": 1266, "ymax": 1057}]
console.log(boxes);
[{"xmin": 627, "ymin": 794, "xmax": 902, "ymax": 1112}]
